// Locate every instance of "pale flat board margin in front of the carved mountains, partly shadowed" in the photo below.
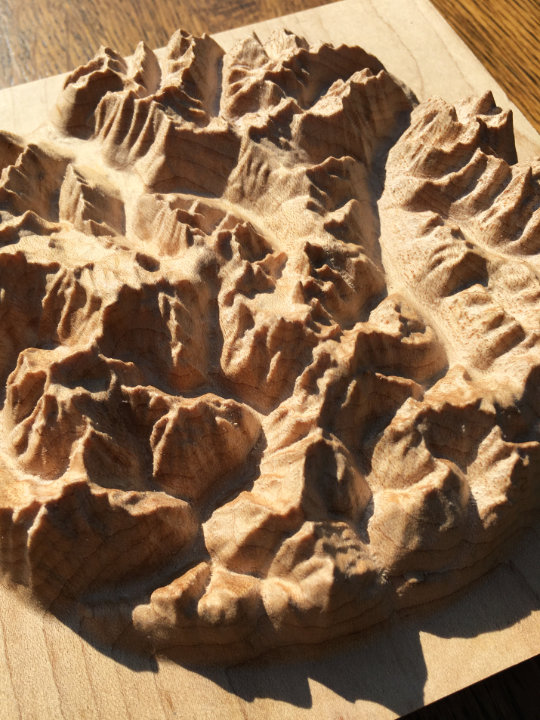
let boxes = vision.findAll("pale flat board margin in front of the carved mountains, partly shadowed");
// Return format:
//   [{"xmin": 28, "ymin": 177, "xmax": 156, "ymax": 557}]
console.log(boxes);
[{"xmin": 0, "ymin": 524, "xmax": 540, "ymax": 720}]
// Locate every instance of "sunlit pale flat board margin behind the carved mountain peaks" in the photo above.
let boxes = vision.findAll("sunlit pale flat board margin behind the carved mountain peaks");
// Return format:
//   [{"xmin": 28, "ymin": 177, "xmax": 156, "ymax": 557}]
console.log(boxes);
[{"xmin": 0, "ymin": 0, "xmax": 539, "ymax": 160}]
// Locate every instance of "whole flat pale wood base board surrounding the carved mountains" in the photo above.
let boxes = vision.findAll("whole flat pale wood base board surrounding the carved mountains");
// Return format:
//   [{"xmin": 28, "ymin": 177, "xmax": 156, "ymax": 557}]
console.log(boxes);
[{"xmin": 0, "ymin": 2, "xmax": 539, "ymax": 718}]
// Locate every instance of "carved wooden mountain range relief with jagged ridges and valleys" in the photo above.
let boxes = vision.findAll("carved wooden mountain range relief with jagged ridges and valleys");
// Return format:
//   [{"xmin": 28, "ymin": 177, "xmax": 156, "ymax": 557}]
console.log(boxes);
[{"xmin": 0, "ymin": 31, "xmax": 540, "ymax": 659}]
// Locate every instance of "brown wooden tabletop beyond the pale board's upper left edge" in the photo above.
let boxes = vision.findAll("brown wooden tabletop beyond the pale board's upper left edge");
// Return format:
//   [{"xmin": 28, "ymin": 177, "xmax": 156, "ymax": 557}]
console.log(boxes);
[{"xmin": 0, "ymin": 0, "xmax": 340, "ymax": 87}]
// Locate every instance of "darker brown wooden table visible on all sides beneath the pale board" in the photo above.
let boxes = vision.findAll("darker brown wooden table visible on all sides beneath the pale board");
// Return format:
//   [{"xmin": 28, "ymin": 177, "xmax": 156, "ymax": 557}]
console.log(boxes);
[{"xmin": 0, "ymin": 0, "xmax": 540, "ymax": 720}]
